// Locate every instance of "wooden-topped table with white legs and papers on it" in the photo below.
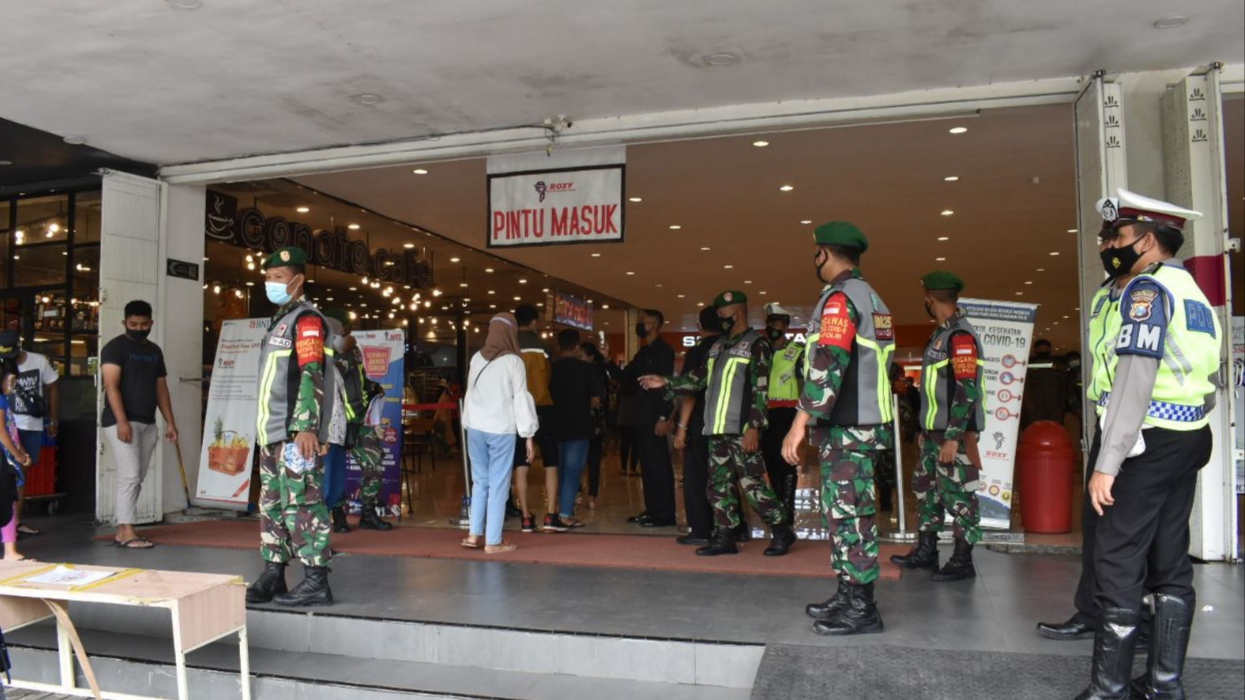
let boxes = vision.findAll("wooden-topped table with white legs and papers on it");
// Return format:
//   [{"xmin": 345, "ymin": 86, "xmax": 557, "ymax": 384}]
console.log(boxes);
[{"xmin": 0, "ymin": 560, "xmax": 250, "ymax": 700}]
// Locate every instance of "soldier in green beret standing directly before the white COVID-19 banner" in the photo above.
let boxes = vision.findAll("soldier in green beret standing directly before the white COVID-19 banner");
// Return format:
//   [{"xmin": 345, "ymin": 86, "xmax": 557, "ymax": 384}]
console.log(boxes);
[{"xmin": 890, "ymin": 272, "xmax": 986, "ymax": 582}]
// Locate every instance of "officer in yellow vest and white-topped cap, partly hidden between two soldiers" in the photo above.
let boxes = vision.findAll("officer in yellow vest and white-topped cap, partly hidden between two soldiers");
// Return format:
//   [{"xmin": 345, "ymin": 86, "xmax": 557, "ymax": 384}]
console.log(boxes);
[{"xmin": 761, "ymin": 304, "xmax": 804, "ymax": 518}]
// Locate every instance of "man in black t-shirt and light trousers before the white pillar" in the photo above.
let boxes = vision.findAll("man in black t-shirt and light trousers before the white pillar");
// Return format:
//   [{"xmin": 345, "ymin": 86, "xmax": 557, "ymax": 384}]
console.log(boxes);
[{"xmin": 100, "ymin": 300, "xmax": 177, "ymax": 549}]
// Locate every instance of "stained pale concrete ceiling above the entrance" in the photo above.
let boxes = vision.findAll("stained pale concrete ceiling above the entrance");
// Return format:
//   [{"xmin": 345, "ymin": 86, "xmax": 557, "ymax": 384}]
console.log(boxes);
[{"xmin": 0, "ymin": 0, "xmax": 1245, "ymax": 164}]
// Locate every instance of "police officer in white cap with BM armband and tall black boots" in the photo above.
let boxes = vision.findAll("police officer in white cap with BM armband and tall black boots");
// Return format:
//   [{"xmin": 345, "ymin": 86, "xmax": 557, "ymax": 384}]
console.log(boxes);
[{"xmin": 1078, "ymin": 189, "xmax": 1223, "ymax": 700}]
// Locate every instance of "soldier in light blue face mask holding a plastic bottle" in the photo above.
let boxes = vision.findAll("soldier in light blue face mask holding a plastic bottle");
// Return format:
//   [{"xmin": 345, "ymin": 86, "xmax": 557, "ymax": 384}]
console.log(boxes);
[{"xmin": 247, "ymin": 248, "xmax": 345, "ymax": 605}]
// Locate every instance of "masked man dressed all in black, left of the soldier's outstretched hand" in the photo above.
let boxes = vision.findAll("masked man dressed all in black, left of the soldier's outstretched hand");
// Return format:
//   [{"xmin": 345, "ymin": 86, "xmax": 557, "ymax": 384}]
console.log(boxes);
[{"xmin": 625, "ymin": 309, "xmax": 676, "ymax": 527}]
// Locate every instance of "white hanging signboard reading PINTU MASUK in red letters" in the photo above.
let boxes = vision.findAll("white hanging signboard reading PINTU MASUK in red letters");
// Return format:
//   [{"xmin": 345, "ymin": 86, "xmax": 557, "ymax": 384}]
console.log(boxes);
[{"xmin": 488, "ymin": 164, "xmax": 625, "ymax": 248}]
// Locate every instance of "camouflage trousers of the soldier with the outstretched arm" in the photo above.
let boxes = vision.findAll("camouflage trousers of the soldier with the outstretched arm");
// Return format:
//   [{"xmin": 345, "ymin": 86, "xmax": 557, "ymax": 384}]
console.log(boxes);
[{"xmin": 706, "ymin": 435, "xmax": 788, "ymax": 529}]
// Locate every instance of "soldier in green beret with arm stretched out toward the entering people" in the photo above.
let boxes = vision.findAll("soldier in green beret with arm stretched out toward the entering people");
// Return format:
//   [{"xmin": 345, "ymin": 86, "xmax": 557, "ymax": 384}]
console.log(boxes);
[{"xmin": 640, "ymin": 291, "xmax": 796, "ymax": 557}]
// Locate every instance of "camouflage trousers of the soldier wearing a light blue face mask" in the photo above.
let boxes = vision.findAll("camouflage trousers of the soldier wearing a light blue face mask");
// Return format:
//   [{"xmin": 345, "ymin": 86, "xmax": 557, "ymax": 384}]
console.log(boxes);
[{"xmin": 259, "ymin": 442, "xmax": 329, "ymax": 567}]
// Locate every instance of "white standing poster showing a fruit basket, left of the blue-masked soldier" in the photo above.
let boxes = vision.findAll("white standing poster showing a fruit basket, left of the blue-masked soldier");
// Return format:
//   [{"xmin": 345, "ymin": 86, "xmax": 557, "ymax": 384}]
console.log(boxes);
[{"xmin": 194, "ymin": 319, "xmax": 268, "ymax": 511}]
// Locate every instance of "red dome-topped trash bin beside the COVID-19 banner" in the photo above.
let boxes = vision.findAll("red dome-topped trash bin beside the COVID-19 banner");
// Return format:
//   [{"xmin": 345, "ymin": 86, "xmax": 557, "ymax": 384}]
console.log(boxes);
[{"xmin": 1016, "ymin": 421, "xmax": 1076, "ymax": 534}]
